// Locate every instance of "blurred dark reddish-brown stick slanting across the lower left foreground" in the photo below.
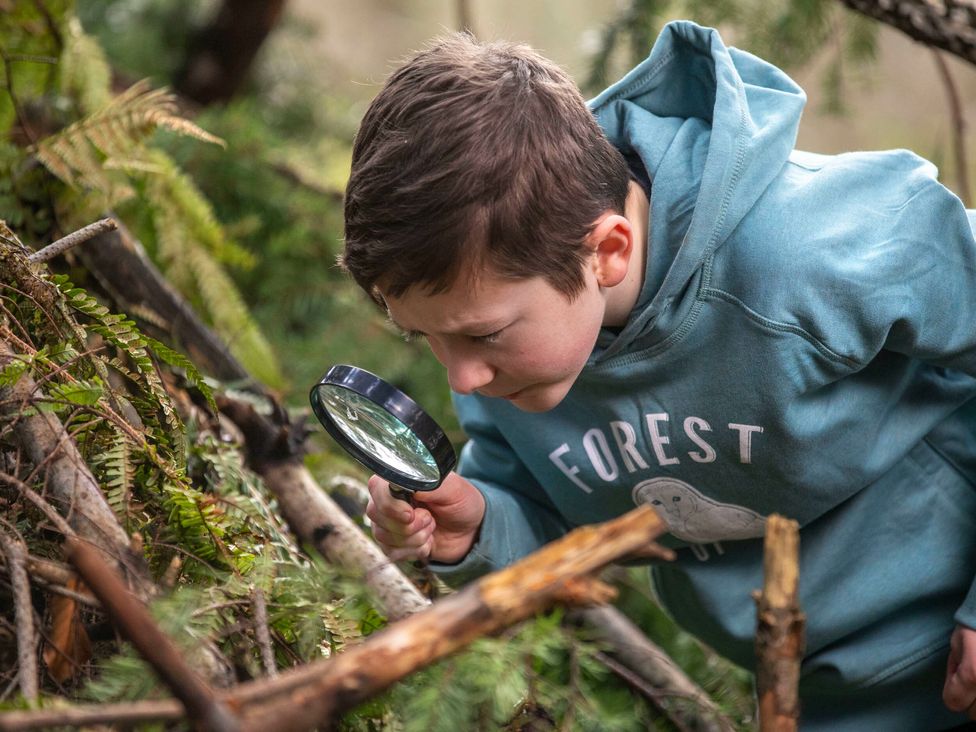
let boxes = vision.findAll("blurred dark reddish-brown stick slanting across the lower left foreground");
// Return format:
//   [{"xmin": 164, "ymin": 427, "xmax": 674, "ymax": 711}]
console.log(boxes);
[{"xmin": 65, "ymin": 539, "xmax": 238, "ymax": 732}]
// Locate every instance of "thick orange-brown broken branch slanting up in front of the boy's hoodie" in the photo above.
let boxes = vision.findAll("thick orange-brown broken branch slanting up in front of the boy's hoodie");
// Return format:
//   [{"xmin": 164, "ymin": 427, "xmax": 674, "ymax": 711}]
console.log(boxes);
[{"xmin": 234, "ymin": 506, "xmax": 665, "ymax": 732}]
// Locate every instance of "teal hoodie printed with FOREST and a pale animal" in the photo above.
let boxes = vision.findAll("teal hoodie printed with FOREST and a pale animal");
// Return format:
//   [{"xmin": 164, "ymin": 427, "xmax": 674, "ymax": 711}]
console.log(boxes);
[{"xmin": 438, "ymin": 22, "xmax": 976, "ymax": 724}]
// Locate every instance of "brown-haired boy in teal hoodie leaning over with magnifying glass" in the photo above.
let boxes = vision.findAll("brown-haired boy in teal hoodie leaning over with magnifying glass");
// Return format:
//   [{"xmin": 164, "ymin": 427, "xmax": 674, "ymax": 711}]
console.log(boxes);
[{"xmin": 343, "ymin": 22, "xmax": 976, "ymax": 732}]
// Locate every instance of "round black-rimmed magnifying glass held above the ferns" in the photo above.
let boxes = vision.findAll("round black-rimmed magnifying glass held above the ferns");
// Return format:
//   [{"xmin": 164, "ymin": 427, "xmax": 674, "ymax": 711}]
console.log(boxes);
[{"xmin": 309, "ymin": 364, "xmax": 457, "ymax": 505}]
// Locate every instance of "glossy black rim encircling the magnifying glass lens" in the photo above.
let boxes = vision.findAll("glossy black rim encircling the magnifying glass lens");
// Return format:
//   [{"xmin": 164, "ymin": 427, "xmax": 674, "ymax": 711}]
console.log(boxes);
[{"xmin": 308, "ymin": 364, "xmax": 457, "ymax": 491}]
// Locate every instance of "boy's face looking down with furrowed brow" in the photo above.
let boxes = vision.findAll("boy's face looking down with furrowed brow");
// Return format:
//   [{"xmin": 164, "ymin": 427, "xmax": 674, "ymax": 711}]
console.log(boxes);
[{"xmin": 384, "ymin": 267, "xmax": 606, "ymax": 412}]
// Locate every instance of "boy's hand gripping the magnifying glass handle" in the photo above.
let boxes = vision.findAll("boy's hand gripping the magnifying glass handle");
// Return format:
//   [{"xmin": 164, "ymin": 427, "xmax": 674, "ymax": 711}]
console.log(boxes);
[{"xmin": 366, "ymin": 473, "xmax": 485, "ymax": 564}]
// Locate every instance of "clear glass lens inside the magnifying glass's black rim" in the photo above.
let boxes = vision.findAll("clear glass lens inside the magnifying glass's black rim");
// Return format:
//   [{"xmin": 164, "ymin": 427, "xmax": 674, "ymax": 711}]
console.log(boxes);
[{"xmin": 315, "ymin": 384, "xmax": 441, "ymax": 485}]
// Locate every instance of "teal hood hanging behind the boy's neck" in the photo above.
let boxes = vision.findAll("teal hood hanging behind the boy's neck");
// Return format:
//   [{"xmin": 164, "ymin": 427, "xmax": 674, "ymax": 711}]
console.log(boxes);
[{"xmin": 589, "ymin": 21, "xmax": 806, "ymax": 362}]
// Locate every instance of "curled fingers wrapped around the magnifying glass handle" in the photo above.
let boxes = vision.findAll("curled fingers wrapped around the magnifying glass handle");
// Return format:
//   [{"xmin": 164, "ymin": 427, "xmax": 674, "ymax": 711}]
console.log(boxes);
[{"xmin": 366, "ymin": 475, "xmax": 435, "ymax": 561}]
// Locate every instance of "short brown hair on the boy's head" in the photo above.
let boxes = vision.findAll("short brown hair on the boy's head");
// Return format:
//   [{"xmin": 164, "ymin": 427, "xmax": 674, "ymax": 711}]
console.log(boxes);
[{"xmin": 341, "ymin": 33, "xmax": 629, "ymax": 302}]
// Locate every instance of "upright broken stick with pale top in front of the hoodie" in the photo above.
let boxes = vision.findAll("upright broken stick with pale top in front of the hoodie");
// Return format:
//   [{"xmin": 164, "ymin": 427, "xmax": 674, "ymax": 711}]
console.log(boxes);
[{"xmin": 755, "ymin": 514, "xmax": 806, "ymax": 732}]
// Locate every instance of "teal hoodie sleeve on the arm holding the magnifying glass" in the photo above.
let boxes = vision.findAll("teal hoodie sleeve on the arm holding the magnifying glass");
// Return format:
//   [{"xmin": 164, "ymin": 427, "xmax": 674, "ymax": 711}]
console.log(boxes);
[{"xmin": 430, "ymin": 397, "xmax": 570, "ymax": 585}]
